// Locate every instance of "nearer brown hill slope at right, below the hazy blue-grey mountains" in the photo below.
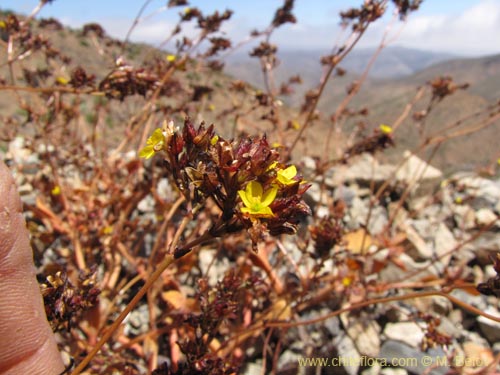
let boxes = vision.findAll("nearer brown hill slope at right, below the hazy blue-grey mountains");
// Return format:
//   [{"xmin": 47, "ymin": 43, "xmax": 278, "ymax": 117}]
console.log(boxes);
[{"xmin": 319, "ymin": 55, "xmax": 500, "ymax": 171}]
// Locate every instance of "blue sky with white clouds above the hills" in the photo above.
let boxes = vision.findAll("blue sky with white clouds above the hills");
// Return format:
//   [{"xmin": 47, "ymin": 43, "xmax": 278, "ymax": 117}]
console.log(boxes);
[{"xmin": 0, "ymin": 0, "xmax": 500, "ymax": 56}]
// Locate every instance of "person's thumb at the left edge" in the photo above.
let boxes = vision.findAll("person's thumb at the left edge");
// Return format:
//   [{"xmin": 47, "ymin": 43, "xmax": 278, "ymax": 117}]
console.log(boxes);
[{"xmin": 0, "ymin": 161, "xmax": 64, "ymax": 375}]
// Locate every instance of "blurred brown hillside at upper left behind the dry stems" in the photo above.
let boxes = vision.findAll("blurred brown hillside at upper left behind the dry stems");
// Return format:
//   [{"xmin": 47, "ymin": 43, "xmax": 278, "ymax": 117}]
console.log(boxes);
[{"xmin": 0, "ymin": 9, "xmax": 282, "ymax": 150}]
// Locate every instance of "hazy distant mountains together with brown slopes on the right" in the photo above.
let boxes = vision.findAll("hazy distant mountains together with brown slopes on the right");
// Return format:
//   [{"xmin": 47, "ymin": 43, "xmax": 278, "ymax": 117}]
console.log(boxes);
[{"xmin": 226, "ymin": 47, "xmax": 500, "ymax": 172}]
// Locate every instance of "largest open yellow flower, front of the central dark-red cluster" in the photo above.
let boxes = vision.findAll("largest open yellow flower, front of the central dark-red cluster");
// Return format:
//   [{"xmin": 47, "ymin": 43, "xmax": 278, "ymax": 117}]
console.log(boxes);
[{"xmin": 238, "ymin": 181, "xmax": 278, "ymax": 217}]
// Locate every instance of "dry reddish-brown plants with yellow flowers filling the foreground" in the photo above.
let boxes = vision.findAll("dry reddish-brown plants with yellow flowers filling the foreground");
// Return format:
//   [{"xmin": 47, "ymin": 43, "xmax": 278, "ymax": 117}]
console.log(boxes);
[{"xmin": 0, "ymin": 0, "xmax": 500, "ymax": 375}]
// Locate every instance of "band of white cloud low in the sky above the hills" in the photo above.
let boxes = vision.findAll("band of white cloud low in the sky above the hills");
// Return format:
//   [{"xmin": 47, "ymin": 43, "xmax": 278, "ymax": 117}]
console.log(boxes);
[{"xmin": 54, "ymin": 0, "xmax": 500, "ymax": 56}]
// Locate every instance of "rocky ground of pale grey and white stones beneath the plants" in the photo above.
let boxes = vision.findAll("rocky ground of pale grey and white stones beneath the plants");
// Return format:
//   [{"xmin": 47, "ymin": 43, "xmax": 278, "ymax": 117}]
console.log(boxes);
[{"xmin": 2, "ymin": 139, "xmax": 500, "ymax": 375}]
